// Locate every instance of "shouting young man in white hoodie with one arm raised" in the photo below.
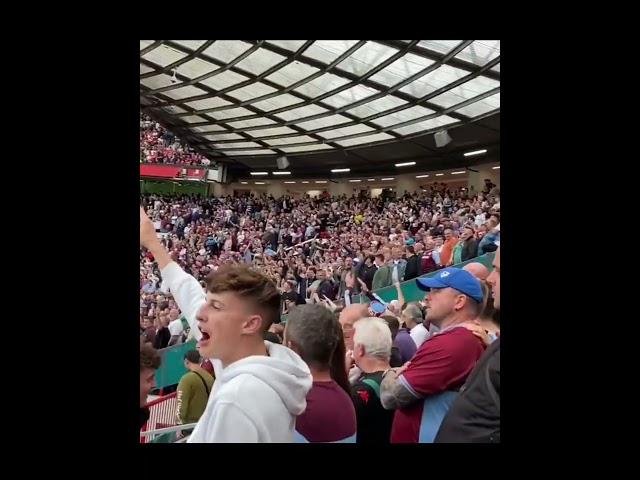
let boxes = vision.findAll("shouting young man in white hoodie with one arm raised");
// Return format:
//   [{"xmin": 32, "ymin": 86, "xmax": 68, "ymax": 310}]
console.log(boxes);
[{"xmin": 140, "ymin": 209, "xmax": 312, "ymax": 443}]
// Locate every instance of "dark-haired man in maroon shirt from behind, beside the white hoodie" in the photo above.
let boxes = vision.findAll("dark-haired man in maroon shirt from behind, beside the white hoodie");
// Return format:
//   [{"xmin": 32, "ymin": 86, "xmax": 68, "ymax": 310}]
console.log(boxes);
[{"xmin": 284, "ymin": 305, "xmax": 356, "ymax": 443}]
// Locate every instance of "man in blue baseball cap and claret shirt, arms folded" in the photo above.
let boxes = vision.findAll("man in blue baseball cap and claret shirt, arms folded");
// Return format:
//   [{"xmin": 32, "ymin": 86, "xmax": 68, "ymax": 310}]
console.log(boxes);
[{"xmin": 381, "ymin": 267, "xmax": 485, "ymax": 443}]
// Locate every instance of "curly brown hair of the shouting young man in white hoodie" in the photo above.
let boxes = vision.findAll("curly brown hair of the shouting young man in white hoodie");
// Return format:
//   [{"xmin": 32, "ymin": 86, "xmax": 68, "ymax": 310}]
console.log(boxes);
[{"xmin": 206, "ymin": 264, "xmax": 280, "ymax": 331}]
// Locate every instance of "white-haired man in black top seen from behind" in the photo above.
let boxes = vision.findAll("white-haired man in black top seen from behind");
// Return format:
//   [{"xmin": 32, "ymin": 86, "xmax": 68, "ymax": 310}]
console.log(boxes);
[{"xmin": 351, "ymin": 317, "xmax": 394, "ymax": 444}]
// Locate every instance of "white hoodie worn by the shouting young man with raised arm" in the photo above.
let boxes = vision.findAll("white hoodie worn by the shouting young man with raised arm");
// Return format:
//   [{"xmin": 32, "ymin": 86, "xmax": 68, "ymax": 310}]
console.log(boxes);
[{"xmin": 162, "ymin": 262, "xmax": 313, "ymax": 443}]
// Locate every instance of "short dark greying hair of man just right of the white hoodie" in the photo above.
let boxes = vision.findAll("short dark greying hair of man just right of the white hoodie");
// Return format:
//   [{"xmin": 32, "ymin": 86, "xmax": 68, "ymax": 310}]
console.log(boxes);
[{"xmin": 286, "ymin": 304, "xmax": 342, "ymax": 367}]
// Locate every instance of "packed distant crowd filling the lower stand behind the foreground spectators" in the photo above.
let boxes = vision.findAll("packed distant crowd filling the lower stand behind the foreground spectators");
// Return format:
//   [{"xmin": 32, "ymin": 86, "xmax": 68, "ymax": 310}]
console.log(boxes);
[{"xmin": 140, "ymin": 184, "xmax": 500, "ymax": 323}]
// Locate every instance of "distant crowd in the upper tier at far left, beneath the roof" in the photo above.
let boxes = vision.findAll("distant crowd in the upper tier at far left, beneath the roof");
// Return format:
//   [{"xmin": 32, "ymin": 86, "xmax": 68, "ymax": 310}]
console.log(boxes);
[{"xmin": 140, "ymin": 113, "xmax": 211, "ymax": 166}]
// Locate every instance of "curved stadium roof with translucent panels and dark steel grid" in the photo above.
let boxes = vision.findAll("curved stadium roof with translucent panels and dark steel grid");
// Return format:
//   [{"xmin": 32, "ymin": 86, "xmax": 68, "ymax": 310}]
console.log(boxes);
[{"xmin": 140, "ymin": 40, "xmax": 500, "ymax": 177}]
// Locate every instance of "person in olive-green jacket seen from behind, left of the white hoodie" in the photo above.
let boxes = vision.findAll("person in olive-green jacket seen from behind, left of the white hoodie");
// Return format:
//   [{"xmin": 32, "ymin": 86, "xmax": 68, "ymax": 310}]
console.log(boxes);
[{"xmin": 176, "ymin": 350, "xmax": 214, "ymax": 433}]
